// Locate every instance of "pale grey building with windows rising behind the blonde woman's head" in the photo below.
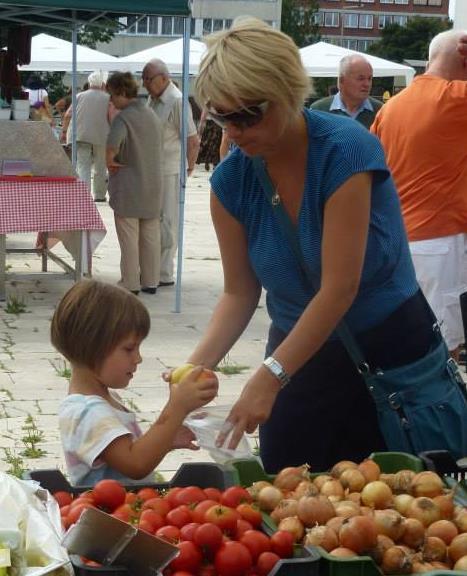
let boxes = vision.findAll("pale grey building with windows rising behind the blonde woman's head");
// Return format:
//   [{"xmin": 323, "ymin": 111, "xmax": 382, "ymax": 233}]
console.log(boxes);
[{"xmin": 98, "ymin": 0, "xmax": 282, "ymax": 56}]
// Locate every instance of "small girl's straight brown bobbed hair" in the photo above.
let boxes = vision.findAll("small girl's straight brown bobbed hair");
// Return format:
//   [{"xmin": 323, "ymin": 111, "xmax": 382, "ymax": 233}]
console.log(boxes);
[{"xmin": 50, "ymin": 280, "xmax": 151, "ymax": 370}]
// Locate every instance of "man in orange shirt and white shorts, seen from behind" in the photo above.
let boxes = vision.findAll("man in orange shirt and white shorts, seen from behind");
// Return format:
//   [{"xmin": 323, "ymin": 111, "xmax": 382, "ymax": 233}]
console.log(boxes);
[{"xmin": 371, "ymin": 30, "xmax": 467, "ymax": 357}]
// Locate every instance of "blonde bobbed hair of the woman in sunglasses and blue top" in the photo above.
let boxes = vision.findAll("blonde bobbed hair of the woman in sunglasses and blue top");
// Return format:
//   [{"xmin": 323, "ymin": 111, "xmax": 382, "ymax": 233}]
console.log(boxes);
[{"xmin": 196, "ymin": 17, "xmax": 310, "ymax": 112}]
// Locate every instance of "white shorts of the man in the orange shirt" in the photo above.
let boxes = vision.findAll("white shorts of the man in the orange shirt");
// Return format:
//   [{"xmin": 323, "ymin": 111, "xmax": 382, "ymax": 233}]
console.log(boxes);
[{"xmin": 409, "ymin": 234, "xmax": 467, "ymax": 350}]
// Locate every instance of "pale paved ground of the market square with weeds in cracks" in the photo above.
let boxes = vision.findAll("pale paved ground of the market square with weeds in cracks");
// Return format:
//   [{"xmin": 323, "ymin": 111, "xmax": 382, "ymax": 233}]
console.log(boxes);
[{"xmin": 0, "ymin": 167, "xmax": 268, "ymax": 478}]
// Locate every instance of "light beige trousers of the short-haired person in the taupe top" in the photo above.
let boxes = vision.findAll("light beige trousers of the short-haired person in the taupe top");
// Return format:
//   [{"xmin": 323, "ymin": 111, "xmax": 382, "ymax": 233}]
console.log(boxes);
[{"xmin": 114, "ymin": 213, "xmax": 161, "ymax": 290}]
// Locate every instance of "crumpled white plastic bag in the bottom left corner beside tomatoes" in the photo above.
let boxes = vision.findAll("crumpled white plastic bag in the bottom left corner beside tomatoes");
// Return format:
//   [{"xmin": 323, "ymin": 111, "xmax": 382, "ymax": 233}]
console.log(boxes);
[{"xmin": 0, "ymin": 472, "xmax": 73, "ymax": 576}]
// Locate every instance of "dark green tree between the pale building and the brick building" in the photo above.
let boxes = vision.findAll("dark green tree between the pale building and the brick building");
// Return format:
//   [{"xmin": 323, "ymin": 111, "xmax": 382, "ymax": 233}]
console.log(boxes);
[{"xmin": 281, "ymin": 0, "xmax": 320, "ymax": 48}]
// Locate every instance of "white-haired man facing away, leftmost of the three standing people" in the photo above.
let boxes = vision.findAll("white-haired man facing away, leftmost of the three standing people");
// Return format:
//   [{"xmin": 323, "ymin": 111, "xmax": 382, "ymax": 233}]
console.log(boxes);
[{"xmin": 61, "ymin": 70, "xmax": 110, "ymax": 202}]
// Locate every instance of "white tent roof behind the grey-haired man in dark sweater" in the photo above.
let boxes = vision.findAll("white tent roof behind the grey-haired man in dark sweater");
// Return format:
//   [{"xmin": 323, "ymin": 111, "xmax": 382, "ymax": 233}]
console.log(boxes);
[{"xmin": 300, "ymin": 42, "xmax": 415, "ymax": 85}]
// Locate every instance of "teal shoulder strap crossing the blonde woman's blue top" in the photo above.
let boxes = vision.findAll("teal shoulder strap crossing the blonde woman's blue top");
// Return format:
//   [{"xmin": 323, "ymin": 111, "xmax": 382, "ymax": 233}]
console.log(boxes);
[{"xmin": 252, "ymin": 156, "xmax": 370, "ymax": 376}]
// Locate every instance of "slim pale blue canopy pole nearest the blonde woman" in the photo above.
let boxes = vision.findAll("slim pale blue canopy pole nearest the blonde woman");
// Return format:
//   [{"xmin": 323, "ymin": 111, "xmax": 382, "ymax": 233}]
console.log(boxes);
[{"xmin": 175, "ymin": 11, "xmax": 191, "ymax": 312}]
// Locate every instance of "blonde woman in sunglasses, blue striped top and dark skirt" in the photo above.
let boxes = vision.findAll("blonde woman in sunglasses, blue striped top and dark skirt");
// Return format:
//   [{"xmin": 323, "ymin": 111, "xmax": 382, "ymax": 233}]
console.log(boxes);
[{"xmin": 189, "ymin": 19, "xmax": 446, "ymax": 472}]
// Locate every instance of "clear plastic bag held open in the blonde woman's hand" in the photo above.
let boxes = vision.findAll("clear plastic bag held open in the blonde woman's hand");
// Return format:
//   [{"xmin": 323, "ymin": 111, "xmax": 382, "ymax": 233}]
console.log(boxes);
[{"xmin": 184, "ymin": 406, "xmax": 254, "ymax": 464}]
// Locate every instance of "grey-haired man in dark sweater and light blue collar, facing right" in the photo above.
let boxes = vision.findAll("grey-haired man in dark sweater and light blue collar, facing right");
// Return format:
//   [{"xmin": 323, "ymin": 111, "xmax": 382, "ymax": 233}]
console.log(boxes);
[{"xmin": 311, "ymin": 54, "xmax": 383, "ymax": 128}]
